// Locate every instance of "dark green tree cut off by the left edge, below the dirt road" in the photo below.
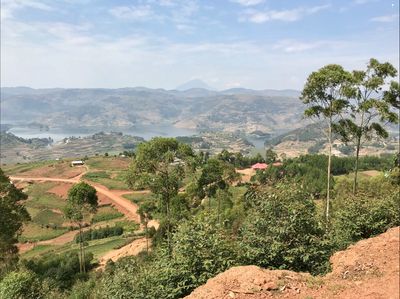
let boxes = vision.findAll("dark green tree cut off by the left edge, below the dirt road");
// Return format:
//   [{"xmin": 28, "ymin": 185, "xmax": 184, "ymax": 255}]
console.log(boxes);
[{"xmin": 0, "ymin": 168, "xmax": 30, "ymax": 277}]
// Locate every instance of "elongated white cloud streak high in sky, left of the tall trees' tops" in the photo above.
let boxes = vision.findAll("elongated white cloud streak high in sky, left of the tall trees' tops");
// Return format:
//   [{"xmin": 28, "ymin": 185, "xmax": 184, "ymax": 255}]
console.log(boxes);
[{"xmin": 239, "ymin": 4, "xmax": 330, "ymax": 24}]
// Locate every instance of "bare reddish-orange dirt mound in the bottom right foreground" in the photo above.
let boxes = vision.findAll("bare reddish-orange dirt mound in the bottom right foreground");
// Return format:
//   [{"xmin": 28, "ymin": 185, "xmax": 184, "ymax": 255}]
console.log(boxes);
[{"xmin": 186, "ymin": 227, "xmax": 400, "ymax": 299}]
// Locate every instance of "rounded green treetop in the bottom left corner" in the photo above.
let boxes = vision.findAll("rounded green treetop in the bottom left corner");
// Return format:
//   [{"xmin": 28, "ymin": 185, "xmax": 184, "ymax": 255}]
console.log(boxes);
[{"xmin": 0, "ymin": 270, "xmax": 44, "ymax": 299}]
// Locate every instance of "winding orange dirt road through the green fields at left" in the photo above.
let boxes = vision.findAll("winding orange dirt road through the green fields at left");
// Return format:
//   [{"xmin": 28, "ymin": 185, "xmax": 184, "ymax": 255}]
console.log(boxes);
[{"xmin": 10, "ymin": 173, "xmax": 159, "ymax": 265}]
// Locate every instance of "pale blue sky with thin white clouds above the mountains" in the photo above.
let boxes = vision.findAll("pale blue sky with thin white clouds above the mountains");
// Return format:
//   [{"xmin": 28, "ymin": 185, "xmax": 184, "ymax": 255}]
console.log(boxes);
[{"xmin": 1, "ymin": 0, "xmax": 399, "ymax": 90}]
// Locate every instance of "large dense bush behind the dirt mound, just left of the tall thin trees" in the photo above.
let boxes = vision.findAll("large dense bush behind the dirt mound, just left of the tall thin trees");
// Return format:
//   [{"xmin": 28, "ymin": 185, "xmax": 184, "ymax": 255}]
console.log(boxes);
[{"xmin": 239, "ymin": 184, "xmax": 331, "ymax": 273}]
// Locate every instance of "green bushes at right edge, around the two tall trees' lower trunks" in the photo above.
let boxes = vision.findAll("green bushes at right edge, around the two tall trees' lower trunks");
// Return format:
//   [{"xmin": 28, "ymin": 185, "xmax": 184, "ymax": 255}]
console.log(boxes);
[{"xmin": 332, "ymin": 177, "xmax": 400, "ymax": 249}]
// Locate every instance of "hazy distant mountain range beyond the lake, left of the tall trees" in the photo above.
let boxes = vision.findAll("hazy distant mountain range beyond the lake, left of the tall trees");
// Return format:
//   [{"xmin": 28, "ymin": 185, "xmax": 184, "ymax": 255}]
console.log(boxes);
[{"xmin": 1, "ymin": 86, "xmax": 304, "ymax": 136}]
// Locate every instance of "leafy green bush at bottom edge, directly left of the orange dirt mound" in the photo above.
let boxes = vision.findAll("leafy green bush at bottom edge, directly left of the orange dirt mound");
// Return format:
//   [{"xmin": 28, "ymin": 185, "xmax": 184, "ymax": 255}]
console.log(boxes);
[{"xmin": 99, "ymin": 214, "xmax": 236, "ymax": 299}]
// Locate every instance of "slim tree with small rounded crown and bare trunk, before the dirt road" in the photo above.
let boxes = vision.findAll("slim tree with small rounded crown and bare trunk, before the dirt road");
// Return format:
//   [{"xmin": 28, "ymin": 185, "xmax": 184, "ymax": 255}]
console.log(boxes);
[{"xmin": 64, "ymin": 182, "xmax": 98, "ymax": 273}]
